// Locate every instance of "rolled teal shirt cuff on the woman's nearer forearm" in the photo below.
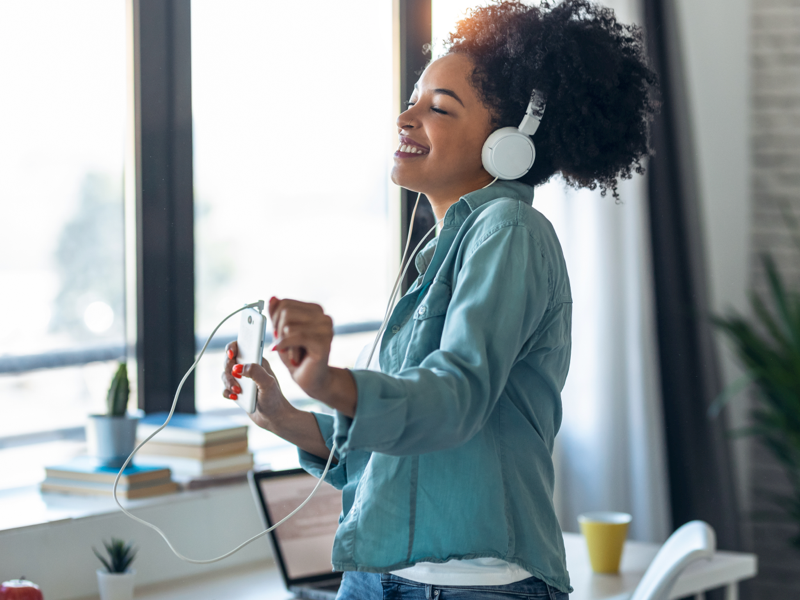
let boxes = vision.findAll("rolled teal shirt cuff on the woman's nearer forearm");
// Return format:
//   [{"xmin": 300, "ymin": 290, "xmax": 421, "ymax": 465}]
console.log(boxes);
[{"xmin": 333, "ymin": 369, "xmax": 407, "ymax": 456}]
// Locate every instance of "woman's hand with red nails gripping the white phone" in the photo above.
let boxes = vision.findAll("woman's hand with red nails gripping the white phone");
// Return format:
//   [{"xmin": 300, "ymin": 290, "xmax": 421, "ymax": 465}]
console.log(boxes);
[{"xmin": 222, "ymin": 341, "xmax": 291, "ymax": 430}]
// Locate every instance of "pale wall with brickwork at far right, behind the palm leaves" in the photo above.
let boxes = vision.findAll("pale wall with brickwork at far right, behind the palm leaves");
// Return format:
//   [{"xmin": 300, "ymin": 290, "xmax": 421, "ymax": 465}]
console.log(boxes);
[{"xmin": 676, "ymin": 0, "xmax": 800, "ymax": 598}]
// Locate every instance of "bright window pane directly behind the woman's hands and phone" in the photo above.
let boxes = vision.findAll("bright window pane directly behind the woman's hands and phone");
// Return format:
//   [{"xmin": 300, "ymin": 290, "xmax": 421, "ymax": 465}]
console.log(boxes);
[{"xmin": 192, "ymin": 0, "xmax": 399, "ymax": 410}]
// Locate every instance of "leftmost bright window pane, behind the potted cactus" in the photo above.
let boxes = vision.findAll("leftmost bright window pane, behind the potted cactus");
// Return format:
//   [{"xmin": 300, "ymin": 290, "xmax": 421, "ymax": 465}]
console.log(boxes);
[{"xmin": 0, "ymin": 0, "xmax": 125, "ymax": 487}]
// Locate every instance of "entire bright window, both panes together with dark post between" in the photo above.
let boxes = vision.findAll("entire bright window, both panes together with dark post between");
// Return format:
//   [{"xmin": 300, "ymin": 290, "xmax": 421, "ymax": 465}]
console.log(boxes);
[{"xmin": 0, "ymin": 0, "xmax": 429, "ymax": 488}]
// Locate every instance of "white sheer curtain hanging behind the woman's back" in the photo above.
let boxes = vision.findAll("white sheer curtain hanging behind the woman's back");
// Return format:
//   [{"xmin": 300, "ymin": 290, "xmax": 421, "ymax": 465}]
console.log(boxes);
[{"xmin": 534, "ymin": 165, "xmax": 671, "ymax": 542}]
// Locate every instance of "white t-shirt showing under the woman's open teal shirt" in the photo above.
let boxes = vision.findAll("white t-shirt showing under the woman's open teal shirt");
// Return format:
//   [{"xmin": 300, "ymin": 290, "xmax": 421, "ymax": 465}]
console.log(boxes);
[{"xmin": 355, "ymin": 340, "xmax": 531, "ymax": 585}]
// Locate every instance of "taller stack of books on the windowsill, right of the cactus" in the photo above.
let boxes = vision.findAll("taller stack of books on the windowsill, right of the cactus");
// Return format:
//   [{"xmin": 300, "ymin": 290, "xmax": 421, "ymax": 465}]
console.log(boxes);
[{"xmin": 134, "ymin": 412, "xmax": 253, "ymax": 482}]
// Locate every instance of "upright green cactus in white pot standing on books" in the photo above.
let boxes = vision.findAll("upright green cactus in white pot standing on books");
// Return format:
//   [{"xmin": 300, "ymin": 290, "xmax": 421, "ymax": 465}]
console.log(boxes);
[{"xmin": 86, "ymin": 362, "xmax": 139, "ymax": 469}]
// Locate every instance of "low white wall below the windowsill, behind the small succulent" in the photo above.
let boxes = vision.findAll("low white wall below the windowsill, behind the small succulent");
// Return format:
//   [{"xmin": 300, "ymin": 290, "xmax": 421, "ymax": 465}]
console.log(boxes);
[{"xmin": 0, "ymin": 484, "xmax": 272, "ymax": 600}]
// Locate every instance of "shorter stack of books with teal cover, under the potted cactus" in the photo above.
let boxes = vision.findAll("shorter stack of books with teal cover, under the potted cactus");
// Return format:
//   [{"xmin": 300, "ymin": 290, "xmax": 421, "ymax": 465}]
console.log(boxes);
[{"xmin": 41, "ymin": 456, "xmax": 178, "ymax": 499}]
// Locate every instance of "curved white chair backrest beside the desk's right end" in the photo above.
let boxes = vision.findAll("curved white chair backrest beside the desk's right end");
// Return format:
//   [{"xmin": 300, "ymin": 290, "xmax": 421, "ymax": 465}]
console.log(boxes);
[{"xmin": 630, "ymin": 521, "xmax": 717, "ymax": 600}]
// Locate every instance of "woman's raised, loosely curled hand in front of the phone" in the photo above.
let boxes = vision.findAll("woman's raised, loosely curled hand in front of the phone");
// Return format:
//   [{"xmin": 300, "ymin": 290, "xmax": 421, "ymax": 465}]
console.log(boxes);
[{"xmin": 268, "ymin": 297, "xmax": 333, "ymax": 398}]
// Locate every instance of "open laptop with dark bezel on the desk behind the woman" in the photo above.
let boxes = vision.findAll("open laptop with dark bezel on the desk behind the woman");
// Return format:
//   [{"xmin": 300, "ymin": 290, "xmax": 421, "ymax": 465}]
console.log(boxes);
[{"xmin": 248, "ymin": 469, "xmax": 342, "ymax": 600}]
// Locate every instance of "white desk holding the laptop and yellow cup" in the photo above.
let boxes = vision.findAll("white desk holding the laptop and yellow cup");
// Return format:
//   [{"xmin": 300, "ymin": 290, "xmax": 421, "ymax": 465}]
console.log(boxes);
[{"xmin": 128, "ymin": 533, "xmax": 757, "ymax": 600}]
